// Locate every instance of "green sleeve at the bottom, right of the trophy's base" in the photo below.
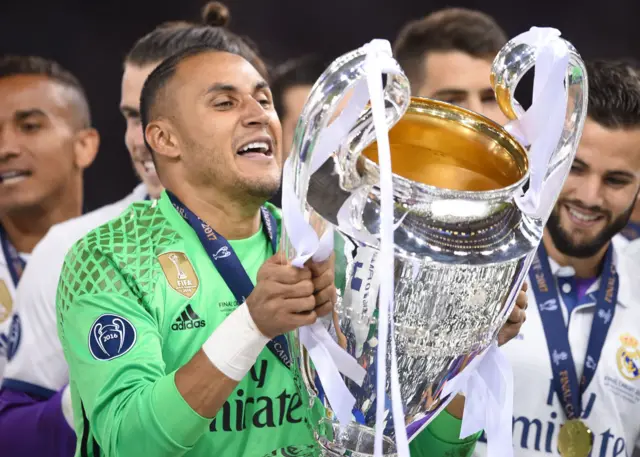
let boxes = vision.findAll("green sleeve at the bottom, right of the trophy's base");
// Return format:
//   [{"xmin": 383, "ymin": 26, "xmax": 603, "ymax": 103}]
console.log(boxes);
[{"xmin": 409, "ymin": 410, "xmax": 482, "ymax": 457}]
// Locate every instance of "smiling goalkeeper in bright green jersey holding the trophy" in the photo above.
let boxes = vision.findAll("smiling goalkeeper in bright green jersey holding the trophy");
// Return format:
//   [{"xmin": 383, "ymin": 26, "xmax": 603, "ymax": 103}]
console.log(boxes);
[{"xmin": 57, "ymin": 34, "xmax": 524, "ymax": 457}]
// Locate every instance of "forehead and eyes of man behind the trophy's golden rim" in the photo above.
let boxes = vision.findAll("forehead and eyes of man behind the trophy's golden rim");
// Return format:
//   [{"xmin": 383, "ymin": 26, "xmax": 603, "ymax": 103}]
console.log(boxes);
[{"xmin": 411, "ymin": 51, "xmax": 508, "ymax": 125}]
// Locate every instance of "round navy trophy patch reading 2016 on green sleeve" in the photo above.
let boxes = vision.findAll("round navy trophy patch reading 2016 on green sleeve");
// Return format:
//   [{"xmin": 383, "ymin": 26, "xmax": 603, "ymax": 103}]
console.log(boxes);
[{"xmin": 89, "ymin": 314, "xmax": 136, "ymax": 360}]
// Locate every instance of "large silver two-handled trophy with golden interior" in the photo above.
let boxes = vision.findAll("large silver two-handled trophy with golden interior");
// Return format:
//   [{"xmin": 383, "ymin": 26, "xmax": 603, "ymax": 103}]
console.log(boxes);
[{"xmin": 274, "ymin": 33, "xmax": 587, "ymax": 457}]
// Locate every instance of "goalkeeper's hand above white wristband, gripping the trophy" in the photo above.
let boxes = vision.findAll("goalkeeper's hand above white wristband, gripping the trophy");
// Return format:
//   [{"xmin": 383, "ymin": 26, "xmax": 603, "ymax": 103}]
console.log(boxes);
[{"xmin": 246, "ymin": 252, "xmax": 318, "ymax": 338}]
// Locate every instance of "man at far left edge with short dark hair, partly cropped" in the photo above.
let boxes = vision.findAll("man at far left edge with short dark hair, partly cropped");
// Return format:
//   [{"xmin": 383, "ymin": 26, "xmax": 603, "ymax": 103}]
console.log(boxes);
[{"xmin": 0, "ymin": 56, "xmax": 100, "ymax": 379}]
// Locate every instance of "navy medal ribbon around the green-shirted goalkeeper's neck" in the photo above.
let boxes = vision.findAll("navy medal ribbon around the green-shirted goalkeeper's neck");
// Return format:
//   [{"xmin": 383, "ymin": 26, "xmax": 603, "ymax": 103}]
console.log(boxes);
[{"xmin": 167, "ymin": 191, "xmax": 291, "ymax": 368}]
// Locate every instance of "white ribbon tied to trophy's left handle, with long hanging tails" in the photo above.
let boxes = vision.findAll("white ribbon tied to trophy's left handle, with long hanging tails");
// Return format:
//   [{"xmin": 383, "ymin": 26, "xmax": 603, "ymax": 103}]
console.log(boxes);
[{"xmin": 282, "ymin": 40, "xmax": 409, "ymax": 457}]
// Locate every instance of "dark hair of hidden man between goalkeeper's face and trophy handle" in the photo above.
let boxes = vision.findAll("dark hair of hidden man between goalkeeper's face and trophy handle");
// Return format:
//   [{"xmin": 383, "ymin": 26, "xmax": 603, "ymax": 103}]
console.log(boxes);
[{"xmin": 270, "ymin": 55, "xmax": 331, "ymax": 118}]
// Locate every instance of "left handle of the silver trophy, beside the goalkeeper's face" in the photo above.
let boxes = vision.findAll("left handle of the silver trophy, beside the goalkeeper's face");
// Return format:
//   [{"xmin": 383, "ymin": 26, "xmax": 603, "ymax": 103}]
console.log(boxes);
[{"xmin": 284, "ymin": 40, "xmax": 411, "ymax": 211}]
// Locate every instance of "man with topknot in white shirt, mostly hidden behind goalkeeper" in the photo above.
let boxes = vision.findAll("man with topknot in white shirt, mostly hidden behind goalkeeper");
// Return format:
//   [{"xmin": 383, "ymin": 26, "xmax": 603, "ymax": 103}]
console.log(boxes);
[{"xmin": 0, "ymin": 4, "xmax": 270, "ymax": 457}]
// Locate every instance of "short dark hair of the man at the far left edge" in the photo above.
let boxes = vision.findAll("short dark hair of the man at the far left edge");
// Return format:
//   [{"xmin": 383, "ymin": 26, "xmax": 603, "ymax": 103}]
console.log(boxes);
[{"xmin": 0, "ymin": 55, "xmax": 91, "ymax": 128}]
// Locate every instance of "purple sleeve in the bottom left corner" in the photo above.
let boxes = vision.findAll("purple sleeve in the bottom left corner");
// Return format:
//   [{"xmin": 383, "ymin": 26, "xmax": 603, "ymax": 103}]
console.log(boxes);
[{"xmin": 0, "ymin": 388, "xmax": 76, "ymax": 457}]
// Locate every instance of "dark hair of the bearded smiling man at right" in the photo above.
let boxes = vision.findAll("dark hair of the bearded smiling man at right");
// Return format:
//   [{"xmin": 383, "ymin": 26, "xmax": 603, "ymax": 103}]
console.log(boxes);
[{"xmin": 585, "ymin": 60, "xmax": 640, "ymax": 129}]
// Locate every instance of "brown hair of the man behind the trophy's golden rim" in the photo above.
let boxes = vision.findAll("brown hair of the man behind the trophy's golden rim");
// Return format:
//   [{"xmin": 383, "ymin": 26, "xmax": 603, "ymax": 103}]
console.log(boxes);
[{"xmin": 394, "ymin": 8, "xmax": 507, "ymax": 85}]
